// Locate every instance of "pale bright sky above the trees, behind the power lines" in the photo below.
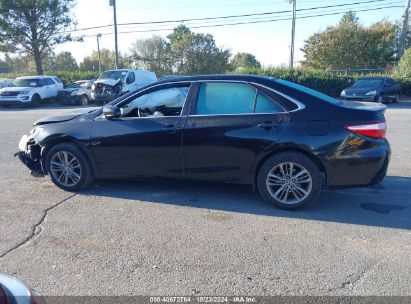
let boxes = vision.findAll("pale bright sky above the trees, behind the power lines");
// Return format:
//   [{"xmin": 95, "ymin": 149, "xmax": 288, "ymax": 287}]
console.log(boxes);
[{"xmin": 56, "ymin": 0, "xmax": 405, "ymax": 66}]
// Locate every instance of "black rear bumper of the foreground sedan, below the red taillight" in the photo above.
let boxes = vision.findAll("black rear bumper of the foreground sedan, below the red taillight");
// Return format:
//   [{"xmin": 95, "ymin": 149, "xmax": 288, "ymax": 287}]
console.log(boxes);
[{"xmin": 323, "ymin": 139, "xmax": 391, "ymax": 187}]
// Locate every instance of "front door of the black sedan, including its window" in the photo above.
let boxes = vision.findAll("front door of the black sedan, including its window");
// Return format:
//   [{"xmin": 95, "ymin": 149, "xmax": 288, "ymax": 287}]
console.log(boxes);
[{"xmin": 91, "ymin": 85, "xmax": 189, "ymax": 177}]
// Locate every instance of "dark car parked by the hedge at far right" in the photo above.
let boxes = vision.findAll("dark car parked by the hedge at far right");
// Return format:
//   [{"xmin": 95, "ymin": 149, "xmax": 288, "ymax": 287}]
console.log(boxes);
[{"xmin": 341, "ymin": 77, "xmax": 400, "ymax": 103}]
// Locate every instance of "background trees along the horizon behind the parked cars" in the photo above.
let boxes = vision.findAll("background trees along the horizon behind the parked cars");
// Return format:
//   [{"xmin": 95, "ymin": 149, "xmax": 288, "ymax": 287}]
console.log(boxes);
[{"xmin": 0, "ymin": 0, "xmax": 411, "ymax": 76}]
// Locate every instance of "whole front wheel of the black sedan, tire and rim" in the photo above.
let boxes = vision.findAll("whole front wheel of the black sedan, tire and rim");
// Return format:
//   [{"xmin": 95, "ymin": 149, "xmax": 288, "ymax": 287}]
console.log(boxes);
[{"xmin": 45, "ymin": 143, "xmax": 94, "ymax": 191}]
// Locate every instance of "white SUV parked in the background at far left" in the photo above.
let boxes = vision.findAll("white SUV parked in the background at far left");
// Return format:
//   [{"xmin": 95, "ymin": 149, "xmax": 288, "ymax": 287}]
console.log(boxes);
[{"xmin": 0, "ymin": 76, "xmax": 63, "ymax": 106}]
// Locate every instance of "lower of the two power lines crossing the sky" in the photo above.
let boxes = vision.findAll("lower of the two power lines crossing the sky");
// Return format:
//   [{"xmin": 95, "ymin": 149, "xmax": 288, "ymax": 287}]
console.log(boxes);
[{"xmin": 76, "ymin": 5, "xmax": 402, "ymax": 38}]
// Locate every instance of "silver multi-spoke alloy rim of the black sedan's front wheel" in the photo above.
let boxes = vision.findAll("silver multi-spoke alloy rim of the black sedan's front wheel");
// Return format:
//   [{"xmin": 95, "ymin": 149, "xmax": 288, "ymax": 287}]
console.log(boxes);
[{"xmin": 50, "ymin": 151, "xmax": 82, "ymax": 187}]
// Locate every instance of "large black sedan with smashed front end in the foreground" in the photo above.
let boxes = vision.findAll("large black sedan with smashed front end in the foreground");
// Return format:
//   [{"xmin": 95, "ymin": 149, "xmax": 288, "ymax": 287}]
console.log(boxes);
[{"xmin": 17, "ymin": 75, "xmax": 390, "ymax": 209}]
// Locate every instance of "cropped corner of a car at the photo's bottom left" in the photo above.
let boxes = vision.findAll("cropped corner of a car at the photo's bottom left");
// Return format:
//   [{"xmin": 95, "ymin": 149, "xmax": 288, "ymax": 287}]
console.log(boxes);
[{"xmin": 0, "ymin": 273, "xmax": 46, "ymax": 304}]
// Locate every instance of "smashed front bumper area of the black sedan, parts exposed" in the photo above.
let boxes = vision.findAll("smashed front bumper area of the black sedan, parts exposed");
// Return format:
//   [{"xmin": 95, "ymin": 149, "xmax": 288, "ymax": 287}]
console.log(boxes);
[{"xmin": 14, "ymin": 135, "xmax": 46, "ymax": 177}]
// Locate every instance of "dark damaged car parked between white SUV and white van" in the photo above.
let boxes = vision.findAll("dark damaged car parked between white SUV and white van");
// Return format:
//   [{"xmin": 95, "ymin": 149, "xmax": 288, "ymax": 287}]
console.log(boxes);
[{"xmin": 57, "ymin": 79, "xmax": 94, "ymax": 106}]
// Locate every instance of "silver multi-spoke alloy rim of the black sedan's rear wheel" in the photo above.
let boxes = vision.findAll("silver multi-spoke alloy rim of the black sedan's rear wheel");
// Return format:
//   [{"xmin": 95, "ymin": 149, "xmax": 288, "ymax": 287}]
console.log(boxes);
[{"xmin": 266, "ymin": 162, "xmax": 313, "ymax": 205}]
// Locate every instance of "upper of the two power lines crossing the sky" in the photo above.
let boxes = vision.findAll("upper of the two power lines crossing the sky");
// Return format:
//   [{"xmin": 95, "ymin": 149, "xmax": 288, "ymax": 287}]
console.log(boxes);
[{"xmin": 65, "ymin": 0, "xmax": 398, "ymax": 33}]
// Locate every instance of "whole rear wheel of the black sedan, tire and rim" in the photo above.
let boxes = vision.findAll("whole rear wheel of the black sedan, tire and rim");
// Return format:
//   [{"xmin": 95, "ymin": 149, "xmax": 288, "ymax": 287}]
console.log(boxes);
[{"xmin": 257, "ymin": 152, "xmax": 322, "ymax": 210}]
